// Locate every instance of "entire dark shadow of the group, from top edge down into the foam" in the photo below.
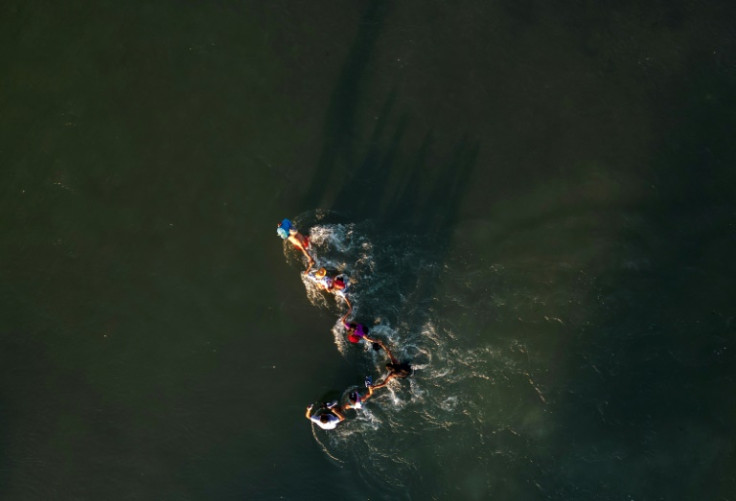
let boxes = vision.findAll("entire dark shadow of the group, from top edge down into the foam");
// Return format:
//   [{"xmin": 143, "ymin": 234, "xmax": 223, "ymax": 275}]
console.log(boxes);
[{"xmin": 301, "ymin": 1, "xmax": 479, "ymax": 364}]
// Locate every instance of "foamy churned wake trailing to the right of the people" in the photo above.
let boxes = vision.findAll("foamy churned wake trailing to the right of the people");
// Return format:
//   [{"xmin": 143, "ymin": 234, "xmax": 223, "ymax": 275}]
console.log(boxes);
[{"xmin": 280, "ymin": 213, "xmax": 543, "ymax": 493}]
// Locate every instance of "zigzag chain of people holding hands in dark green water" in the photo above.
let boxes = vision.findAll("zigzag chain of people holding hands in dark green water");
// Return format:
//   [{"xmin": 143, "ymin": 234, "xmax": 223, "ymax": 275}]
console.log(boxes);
[{"xmin": 276, "ymin": 219, "xmax": 412, "ymax": 430}]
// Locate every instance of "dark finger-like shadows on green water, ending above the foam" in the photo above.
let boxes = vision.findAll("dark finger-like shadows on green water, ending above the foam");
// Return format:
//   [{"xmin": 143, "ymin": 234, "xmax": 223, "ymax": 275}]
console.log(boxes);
[{"xmin": 301, "ymin": 1, "xmax": 478, "ymax": 242}]
